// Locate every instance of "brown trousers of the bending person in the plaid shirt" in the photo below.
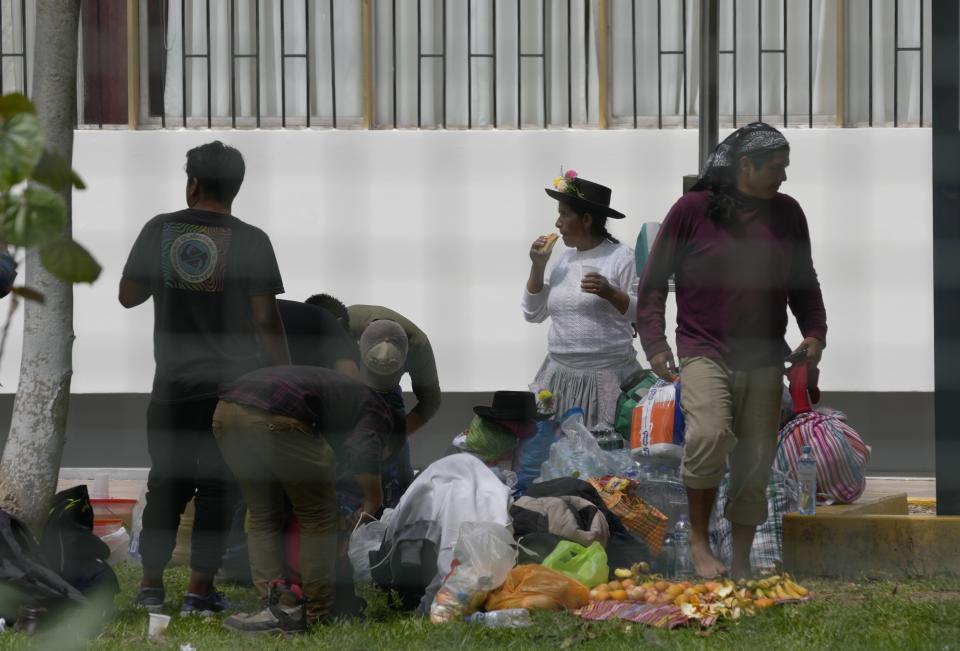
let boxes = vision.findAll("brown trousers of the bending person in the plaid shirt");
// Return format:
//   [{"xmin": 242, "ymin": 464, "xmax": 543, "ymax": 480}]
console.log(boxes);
[{"xmin": 213, "ymin": 401, "xmax": 338, "ymax": 621}]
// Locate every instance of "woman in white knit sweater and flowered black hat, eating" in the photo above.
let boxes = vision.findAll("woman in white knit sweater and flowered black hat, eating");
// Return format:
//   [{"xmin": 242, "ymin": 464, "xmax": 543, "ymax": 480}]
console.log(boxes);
[{"xmin": 523, "ymin": 170, "xmax": 640, "ymax": 427}]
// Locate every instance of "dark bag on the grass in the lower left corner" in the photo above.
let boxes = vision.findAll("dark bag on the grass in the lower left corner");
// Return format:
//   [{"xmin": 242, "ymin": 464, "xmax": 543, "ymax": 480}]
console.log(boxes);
[{"xmin": 0, "ymin": 509, "xmax": 87, "ymax": 622}]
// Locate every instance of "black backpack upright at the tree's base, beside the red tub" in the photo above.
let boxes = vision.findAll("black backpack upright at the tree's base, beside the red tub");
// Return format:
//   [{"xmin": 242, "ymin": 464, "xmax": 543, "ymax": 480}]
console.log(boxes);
[{"xmin": 40, "ymin": 484, "xmax": 120, "ymax": 597}]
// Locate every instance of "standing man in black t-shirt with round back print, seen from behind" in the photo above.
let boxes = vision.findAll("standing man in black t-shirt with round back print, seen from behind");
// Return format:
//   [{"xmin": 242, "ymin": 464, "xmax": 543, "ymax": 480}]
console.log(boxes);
[{"xmin": 119, "ymin": 141, "xmax": 290, "ymax": 613}]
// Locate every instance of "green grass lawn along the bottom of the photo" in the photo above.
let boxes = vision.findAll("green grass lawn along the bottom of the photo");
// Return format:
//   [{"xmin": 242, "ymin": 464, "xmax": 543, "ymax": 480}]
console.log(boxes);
[{"xmin": 0, "ymin": 566, "xmax": 960, "ymax": 651}]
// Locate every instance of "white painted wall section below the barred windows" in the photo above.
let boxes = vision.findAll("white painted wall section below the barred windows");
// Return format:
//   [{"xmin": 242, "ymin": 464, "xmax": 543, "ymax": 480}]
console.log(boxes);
[{"xmin": 0, "ymin": 129, "xmax": 933, "ymax": 393}]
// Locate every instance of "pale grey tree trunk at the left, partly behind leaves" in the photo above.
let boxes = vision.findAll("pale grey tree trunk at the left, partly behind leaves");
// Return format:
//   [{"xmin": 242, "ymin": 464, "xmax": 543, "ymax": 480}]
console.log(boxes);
[{"xmin": 0, "ymin": 0, "xmax": 80, "ymax": 532}]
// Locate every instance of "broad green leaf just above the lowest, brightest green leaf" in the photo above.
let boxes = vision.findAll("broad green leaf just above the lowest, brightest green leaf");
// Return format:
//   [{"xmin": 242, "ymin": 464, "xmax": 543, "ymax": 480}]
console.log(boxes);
[{"xmin": 0, "ymin": 186, "xmax": 67, "ymax": 248}]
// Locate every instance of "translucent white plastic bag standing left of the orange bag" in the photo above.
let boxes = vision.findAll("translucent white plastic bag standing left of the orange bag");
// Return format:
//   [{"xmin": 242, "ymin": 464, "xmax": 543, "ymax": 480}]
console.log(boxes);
[{"xmin": 430, "ymin": 522, "xmax": 517, "ymax": 624}]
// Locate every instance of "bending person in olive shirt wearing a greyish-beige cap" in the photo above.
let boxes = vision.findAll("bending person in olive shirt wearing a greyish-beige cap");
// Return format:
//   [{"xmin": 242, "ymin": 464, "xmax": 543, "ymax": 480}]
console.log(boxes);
[{"xmin": 306, "ymin": 294, "xmax": 441, "ymax": 507}]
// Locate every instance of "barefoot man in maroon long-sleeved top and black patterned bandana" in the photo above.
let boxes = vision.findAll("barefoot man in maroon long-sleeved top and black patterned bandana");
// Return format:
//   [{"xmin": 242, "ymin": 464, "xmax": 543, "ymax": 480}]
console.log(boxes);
[{"xmin": 637, "ymin": 122, "xmax": 827, "ymax": 577}]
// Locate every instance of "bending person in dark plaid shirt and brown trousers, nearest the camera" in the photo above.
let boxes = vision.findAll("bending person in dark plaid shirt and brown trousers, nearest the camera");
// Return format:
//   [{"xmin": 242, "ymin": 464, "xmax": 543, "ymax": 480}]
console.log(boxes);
[{"xmin": 213, "ymin": 366, "xmax": 405, "ymax": 634}]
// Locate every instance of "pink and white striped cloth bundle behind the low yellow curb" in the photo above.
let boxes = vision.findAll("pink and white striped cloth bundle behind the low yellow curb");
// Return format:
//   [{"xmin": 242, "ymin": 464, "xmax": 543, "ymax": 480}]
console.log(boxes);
[{"xmin": 776, "ymin": 407, "xmax": 870, "ymax": 504}]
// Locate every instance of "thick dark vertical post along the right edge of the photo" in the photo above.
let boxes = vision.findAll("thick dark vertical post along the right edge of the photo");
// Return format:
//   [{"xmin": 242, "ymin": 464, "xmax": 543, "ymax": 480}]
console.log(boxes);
[{"xmin": 932, "ymin": 0, "xmax": 960, "ymax": 515}]
